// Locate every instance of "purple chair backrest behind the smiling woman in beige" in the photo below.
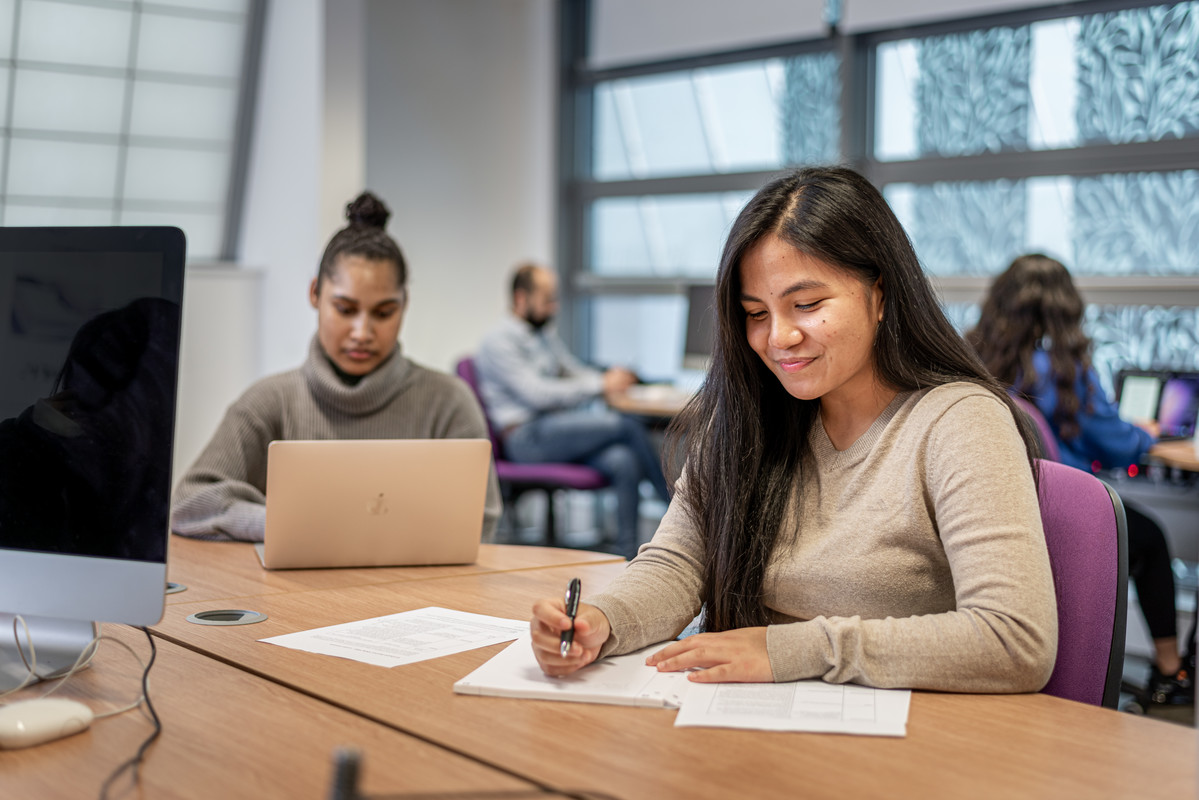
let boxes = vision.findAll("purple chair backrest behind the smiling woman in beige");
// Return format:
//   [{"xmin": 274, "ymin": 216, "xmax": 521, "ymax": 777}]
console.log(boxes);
[{"xmin": 1037, "ymin": 459, "xmax": 1128, "ymax": 709}]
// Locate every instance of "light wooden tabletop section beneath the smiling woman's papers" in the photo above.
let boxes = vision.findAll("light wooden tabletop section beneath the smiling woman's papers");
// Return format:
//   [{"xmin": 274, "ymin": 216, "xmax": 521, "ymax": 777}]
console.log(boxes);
[{"xmin": 155, "ymin": 556, "xmax": 1197, "ymax": 800}]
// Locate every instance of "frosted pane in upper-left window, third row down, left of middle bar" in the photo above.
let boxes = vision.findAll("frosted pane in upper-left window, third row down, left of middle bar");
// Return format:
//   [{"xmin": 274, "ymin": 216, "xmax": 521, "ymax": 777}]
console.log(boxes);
[{"xmin": 7, "ymin": 139, "xmax": 118, "ymax": 200}]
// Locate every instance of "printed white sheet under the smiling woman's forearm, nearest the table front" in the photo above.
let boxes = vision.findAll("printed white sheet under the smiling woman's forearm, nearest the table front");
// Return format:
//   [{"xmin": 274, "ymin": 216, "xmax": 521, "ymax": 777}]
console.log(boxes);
[{"xmin": 675, "ymin": 680, "xmax": 911, "ymax": 736}]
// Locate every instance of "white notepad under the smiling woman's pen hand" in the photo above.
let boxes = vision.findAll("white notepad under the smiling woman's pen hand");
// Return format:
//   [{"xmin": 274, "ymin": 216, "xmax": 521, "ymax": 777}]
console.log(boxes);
[{"xmin": 453, "ymin": 634, "xmax": 689, "ymax": 709}]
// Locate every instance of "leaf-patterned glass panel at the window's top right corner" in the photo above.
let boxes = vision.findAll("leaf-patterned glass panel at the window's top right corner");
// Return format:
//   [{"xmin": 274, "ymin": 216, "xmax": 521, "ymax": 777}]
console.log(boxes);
[{"xmin": 1078, "ymin": 2, "xmax": 1199, "ymax": 143}]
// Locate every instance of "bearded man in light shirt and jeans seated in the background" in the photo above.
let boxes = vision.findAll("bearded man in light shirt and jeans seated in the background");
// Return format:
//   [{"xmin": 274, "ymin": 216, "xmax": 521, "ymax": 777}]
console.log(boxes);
[{"xmin": 475, "ymin": 264, "xmax": 668, "ymax": 558}]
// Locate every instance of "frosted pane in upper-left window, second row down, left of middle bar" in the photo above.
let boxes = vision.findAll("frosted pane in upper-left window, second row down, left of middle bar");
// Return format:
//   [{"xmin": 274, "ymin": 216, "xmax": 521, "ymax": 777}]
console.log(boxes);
[{"xmin": 12, "ymin": 70, "xmax": 125, "ymax": 136}]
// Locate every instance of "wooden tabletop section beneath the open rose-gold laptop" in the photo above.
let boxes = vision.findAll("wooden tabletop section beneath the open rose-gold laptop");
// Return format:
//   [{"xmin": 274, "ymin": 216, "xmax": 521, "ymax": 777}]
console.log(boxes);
[{"xmin": 167, "ymin": 536, "xmax": 623, "ymax": 603}]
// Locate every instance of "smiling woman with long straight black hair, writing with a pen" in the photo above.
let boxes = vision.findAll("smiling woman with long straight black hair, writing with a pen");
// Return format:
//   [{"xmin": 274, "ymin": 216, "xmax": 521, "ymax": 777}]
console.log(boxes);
[{"xmin": 531, "ymin": 168, "xmax": 1058, "ymax": 692}]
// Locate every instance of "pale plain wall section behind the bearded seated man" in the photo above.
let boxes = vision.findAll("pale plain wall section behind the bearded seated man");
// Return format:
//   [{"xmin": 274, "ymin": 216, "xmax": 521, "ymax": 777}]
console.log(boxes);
[{"xmin": 366, "ymin": 0, "xmax": 556, "ymax": 371}]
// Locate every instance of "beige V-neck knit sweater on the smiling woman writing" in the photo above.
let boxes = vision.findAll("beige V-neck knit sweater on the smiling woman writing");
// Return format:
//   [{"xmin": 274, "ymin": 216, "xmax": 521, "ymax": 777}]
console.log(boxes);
[{"xmin": 585, "ymin": 383, "xmax": 1058, "ymax": 692}]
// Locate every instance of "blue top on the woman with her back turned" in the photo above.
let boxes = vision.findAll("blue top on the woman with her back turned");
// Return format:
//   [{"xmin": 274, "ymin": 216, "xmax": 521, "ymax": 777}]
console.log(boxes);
[{"xmin": 1025, "ymin": 350, "xmax": 1153, "ymax": 471}]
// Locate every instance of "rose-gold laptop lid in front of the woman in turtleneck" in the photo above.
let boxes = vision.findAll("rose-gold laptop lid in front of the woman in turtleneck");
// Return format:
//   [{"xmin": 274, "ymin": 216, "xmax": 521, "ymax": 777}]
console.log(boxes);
[{"xmin": 263, "ymin": 439, "xmax": 492, "ymax": 570}]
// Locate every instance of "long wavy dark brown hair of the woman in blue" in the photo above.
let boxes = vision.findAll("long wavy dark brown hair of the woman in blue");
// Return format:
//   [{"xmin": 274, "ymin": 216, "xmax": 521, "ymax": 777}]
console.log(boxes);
[{"xmin": 966, "ymin": 253, "xmax": 1091, "ymax": 439}]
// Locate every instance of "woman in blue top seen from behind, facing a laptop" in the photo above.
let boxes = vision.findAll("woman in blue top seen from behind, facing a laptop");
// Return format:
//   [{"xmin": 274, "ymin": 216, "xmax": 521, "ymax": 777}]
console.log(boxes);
[{"xmin": 966, "ymin": 253, "xmax": 1194, "ymax": 704}]
